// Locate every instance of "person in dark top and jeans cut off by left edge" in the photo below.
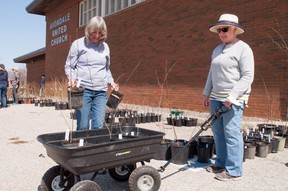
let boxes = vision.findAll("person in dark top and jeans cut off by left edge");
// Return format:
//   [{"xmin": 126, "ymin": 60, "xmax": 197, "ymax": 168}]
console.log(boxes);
[{"xmin": 0, "ymin": 64, "xmax": 9, "ymax": 108}]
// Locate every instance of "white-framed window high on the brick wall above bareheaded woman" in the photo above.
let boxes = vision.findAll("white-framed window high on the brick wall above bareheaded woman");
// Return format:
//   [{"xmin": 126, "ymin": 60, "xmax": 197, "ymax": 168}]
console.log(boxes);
[{"xmin": 79, "ymin": 0, "xmax": 145, "ymax": 27}]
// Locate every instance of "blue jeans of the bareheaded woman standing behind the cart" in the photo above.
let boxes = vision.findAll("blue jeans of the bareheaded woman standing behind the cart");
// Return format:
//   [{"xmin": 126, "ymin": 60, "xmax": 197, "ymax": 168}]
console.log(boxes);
[{"xmin": 76, "ymin": 89, "xmax": 107, "ymax": 130}]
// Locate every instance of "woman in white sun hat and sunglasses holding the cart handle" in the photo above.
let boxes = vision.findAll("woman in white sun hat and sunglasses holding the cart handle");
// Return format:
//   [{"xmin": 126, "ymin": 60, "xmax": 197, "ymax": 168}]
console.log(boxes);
[{"xmin": 203, "ymin": 14, "xmax": 254, "ymax": 181}]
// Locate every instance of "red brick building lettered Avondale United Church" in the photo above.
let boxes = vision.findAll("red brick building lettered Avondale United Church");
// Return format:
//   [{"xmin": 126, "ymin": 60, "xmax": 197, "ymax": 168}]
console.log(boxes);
[{"xmin": 13, "ymin": 0, "xmax": 288, "ymax": 120}]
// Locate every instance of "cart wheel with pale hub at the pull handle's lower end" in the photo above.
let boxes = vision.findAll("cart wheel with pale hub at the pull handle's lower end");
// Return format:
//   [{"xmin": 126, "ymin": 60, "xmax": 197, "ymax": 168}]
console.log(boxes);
[{"xmin": 129, "ymin": 166, "xmax": 161, "ymax": 191}]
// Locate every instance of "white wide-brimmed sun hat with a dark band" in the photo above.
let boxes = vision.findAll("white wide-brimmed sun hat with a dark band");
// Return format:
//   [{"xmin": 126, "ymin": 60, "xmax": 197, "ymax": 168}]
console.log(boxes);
[{"xmin": 209, "ymin": 14, "xmax": 244, "ymax": 34}]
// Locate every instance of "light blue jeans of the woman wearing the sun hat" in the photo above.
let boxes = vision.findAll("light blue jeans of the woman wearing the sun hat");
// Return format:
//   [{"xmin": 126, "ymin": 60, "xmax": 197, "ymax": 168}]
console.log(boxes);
[{"xmin": 210, "ymin": 100, "xmax": 244, "ymax": 176}]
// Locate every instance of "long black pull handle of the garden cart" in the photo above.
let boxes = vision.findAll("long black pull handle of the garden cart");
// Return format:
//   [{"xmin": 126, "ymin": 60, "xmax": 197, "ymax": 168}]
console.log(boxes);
[{"xmin": 158, "ymin": 104, "xmax": 232, "ymax": 172}]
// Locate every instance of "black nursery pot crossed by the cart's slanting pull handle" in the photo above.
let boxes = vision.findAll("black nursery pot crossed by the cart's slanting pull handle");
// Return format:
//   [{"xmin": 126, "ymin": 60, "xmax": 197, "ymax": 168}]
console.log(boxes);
[{"xmin": 171, "ymin": 140, "xmax": 189, "ymax": 164}]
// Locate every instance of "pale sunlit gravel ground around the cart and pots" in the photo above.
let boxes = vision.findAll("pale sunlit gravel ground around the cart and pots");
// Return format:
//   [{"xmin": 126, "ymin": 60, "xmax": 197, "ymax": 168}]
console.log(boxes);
[{"xmin": 0, "ymin": 104, "xmax": 288, "ymax": 191}]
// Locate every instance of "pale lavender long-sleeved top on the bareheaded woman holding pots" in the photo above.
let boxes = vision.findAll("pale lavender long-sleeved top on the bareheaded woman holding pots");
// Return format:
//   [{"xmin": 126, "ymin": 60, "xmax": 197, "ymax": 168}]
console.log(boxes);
[{"xmin": 65, "ymin": 37, "xmax": 114, "ymax": 91}]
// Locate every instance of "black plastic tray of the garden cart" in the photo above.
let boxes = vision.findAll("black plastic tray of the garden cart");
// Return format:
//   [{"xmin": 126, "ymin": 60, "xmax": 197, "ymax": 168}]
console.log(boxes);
[{"xmin": 37, "ymin": 127, "xmax": 164, "ymax": 175}]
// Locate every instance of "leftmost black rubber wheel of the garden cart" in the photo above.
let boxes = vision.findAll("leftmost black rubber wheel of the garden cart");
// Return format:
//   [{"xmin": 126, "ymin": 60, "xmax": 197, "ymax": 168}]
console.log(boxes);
[{"xmin": 38, "ymin": 165, "xmax": 75, "ymax": 191}]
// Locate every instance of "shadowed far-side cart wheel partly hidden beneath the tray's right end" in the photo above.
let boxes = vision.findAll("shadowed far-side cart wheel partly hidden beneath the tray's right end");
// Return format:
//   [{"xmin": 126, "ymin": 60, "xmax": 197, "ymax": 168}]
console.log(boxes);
[{"xmin": 108, "ymin": 164, "xmax": 136, "ymax": 182}]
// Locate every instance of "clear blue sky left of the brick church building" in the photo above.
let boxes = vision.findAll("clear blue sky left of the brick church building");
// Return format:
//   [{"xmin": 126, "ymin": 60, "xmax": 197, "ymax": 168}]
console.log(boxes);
[{"xmin": 0, "ymin": 0, "xmax": 46, "ymax": 70}]
